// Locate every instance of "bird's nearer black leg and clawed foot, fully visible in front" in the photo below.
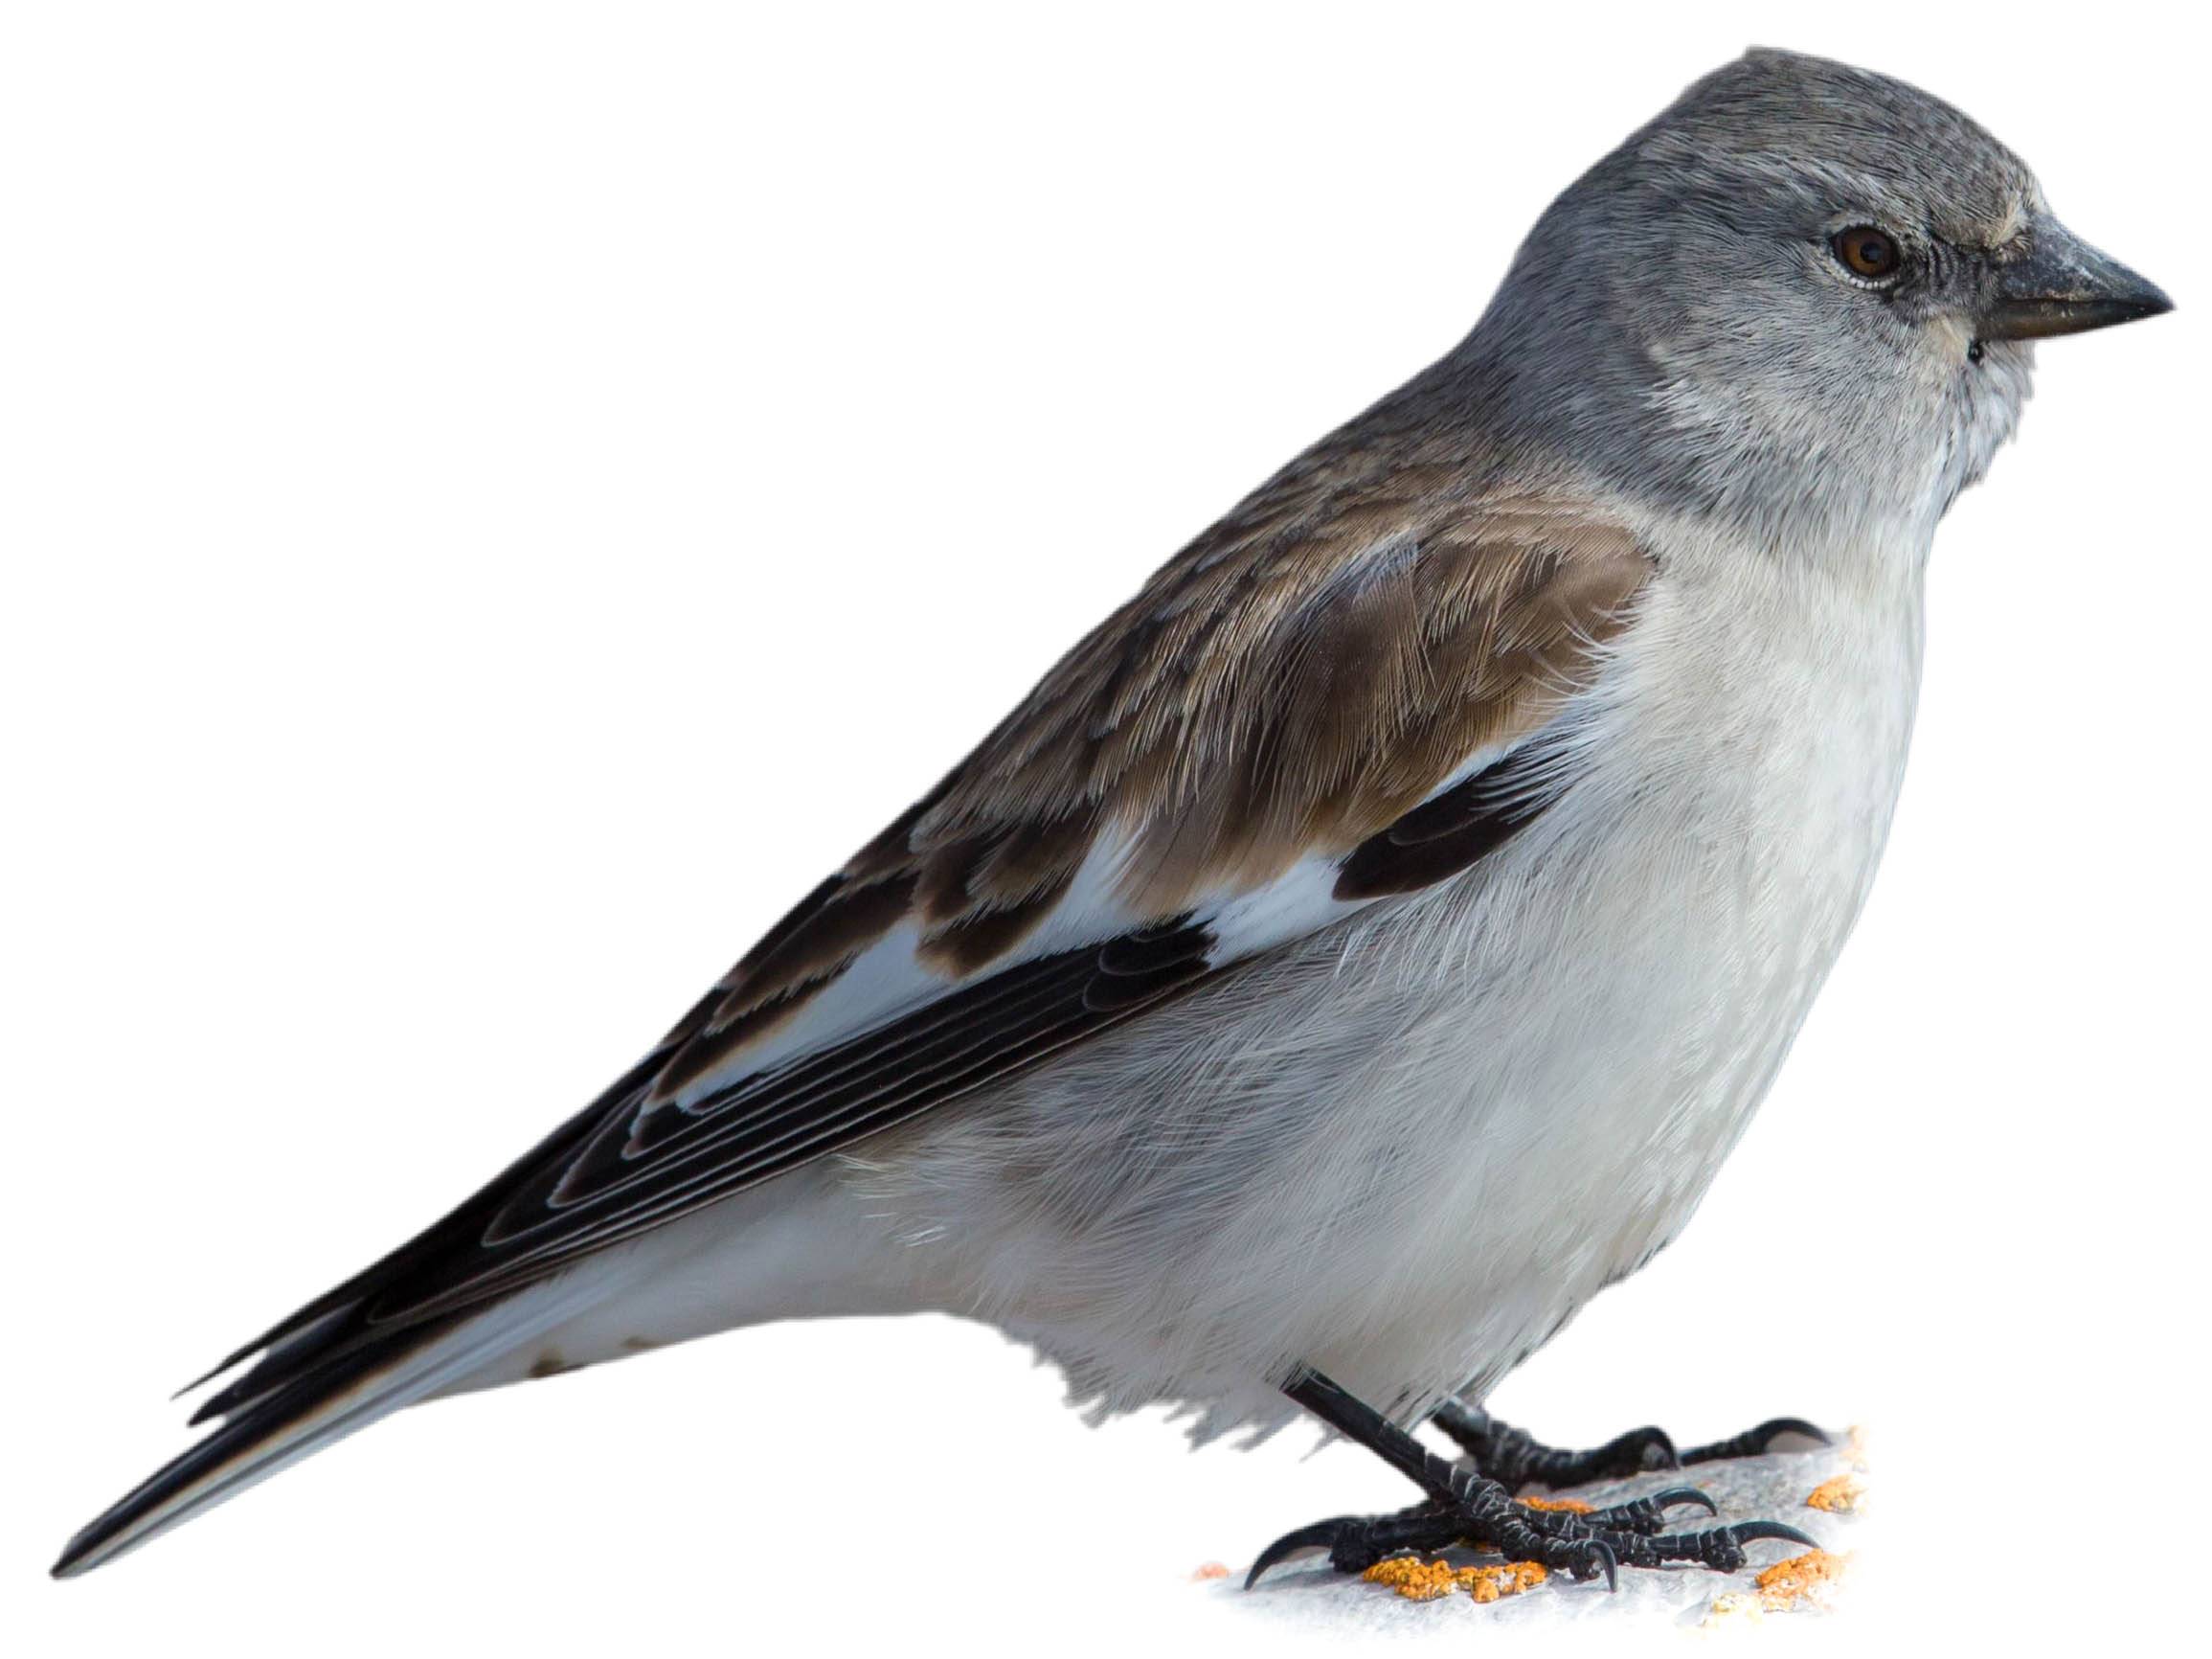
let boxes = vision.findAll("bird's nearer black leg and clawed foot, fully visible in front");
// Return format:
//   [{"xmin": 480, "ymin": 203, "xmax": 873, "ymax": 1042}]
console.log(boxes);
[{"xmin": 1246, "ymin": 1369, "xmax": 1814, "ymax": 1588}]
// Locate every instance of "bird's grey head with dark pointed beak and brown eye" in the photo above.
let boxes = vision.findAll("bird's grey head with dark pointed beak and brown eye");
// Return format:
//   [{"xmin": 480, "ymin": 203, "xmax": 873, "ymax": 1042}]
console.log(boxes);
[{"xmin": 1438, "ymin": 51, "xmax": 2170, "ymax": 537}]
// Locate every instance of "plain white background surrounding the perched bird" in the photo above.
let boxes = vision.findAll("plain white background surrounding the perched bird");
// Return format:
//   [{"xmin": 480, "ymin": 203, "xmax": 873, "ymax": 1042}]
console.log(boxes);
[{"xmin": 0, "ymin": 5, "xmax": 2207, "ymax": 1654}]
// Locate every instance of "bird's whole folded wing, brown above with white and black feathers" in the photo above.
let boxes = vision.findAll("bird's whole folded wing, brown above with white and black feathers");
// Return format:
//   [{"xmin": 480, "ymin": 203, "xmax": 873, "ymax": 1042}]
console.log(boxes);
[{"xmin": 201, "ymin": 470, "xmax": 1648, "ymax": 1416}]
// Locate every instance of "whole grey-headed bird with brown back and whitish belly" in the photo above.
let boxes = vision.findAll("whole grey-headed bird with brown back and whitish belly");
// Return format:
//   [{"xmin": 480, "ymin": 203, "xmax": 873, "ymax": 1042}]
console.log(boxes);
[{"xmin": 53, "ymin": 49, "xmax": 2172, "ymax": 1581}]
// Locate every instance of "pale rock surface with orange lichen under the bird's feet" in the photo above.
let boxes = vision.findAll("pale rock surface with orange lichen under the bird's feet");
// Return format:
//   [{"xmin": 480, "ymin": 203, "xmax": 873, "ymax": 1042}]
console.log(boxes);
[{"xmin": 1208, "ymin": 1431, "xmax": 1864, "ymax": 1639}]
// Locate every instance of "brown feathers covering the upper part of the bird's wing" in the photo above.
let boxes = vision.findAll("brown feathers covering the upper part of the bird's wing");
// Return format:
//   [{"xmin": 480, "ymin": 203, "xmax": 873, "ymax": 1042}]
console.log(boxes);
[{"xmin": 914, "ymin": 492, "xmax": 1650, "ymax": 914}]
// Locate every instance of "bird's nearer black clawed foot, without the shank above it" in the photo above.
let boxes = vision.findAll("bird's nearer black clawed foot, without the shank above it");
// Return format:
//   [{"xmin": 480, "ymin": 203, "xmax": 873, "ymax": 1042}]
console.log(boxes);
[{"xmin": 1246, "ymin": 1471, "xmax": 1817, "ymax": 1590}]
